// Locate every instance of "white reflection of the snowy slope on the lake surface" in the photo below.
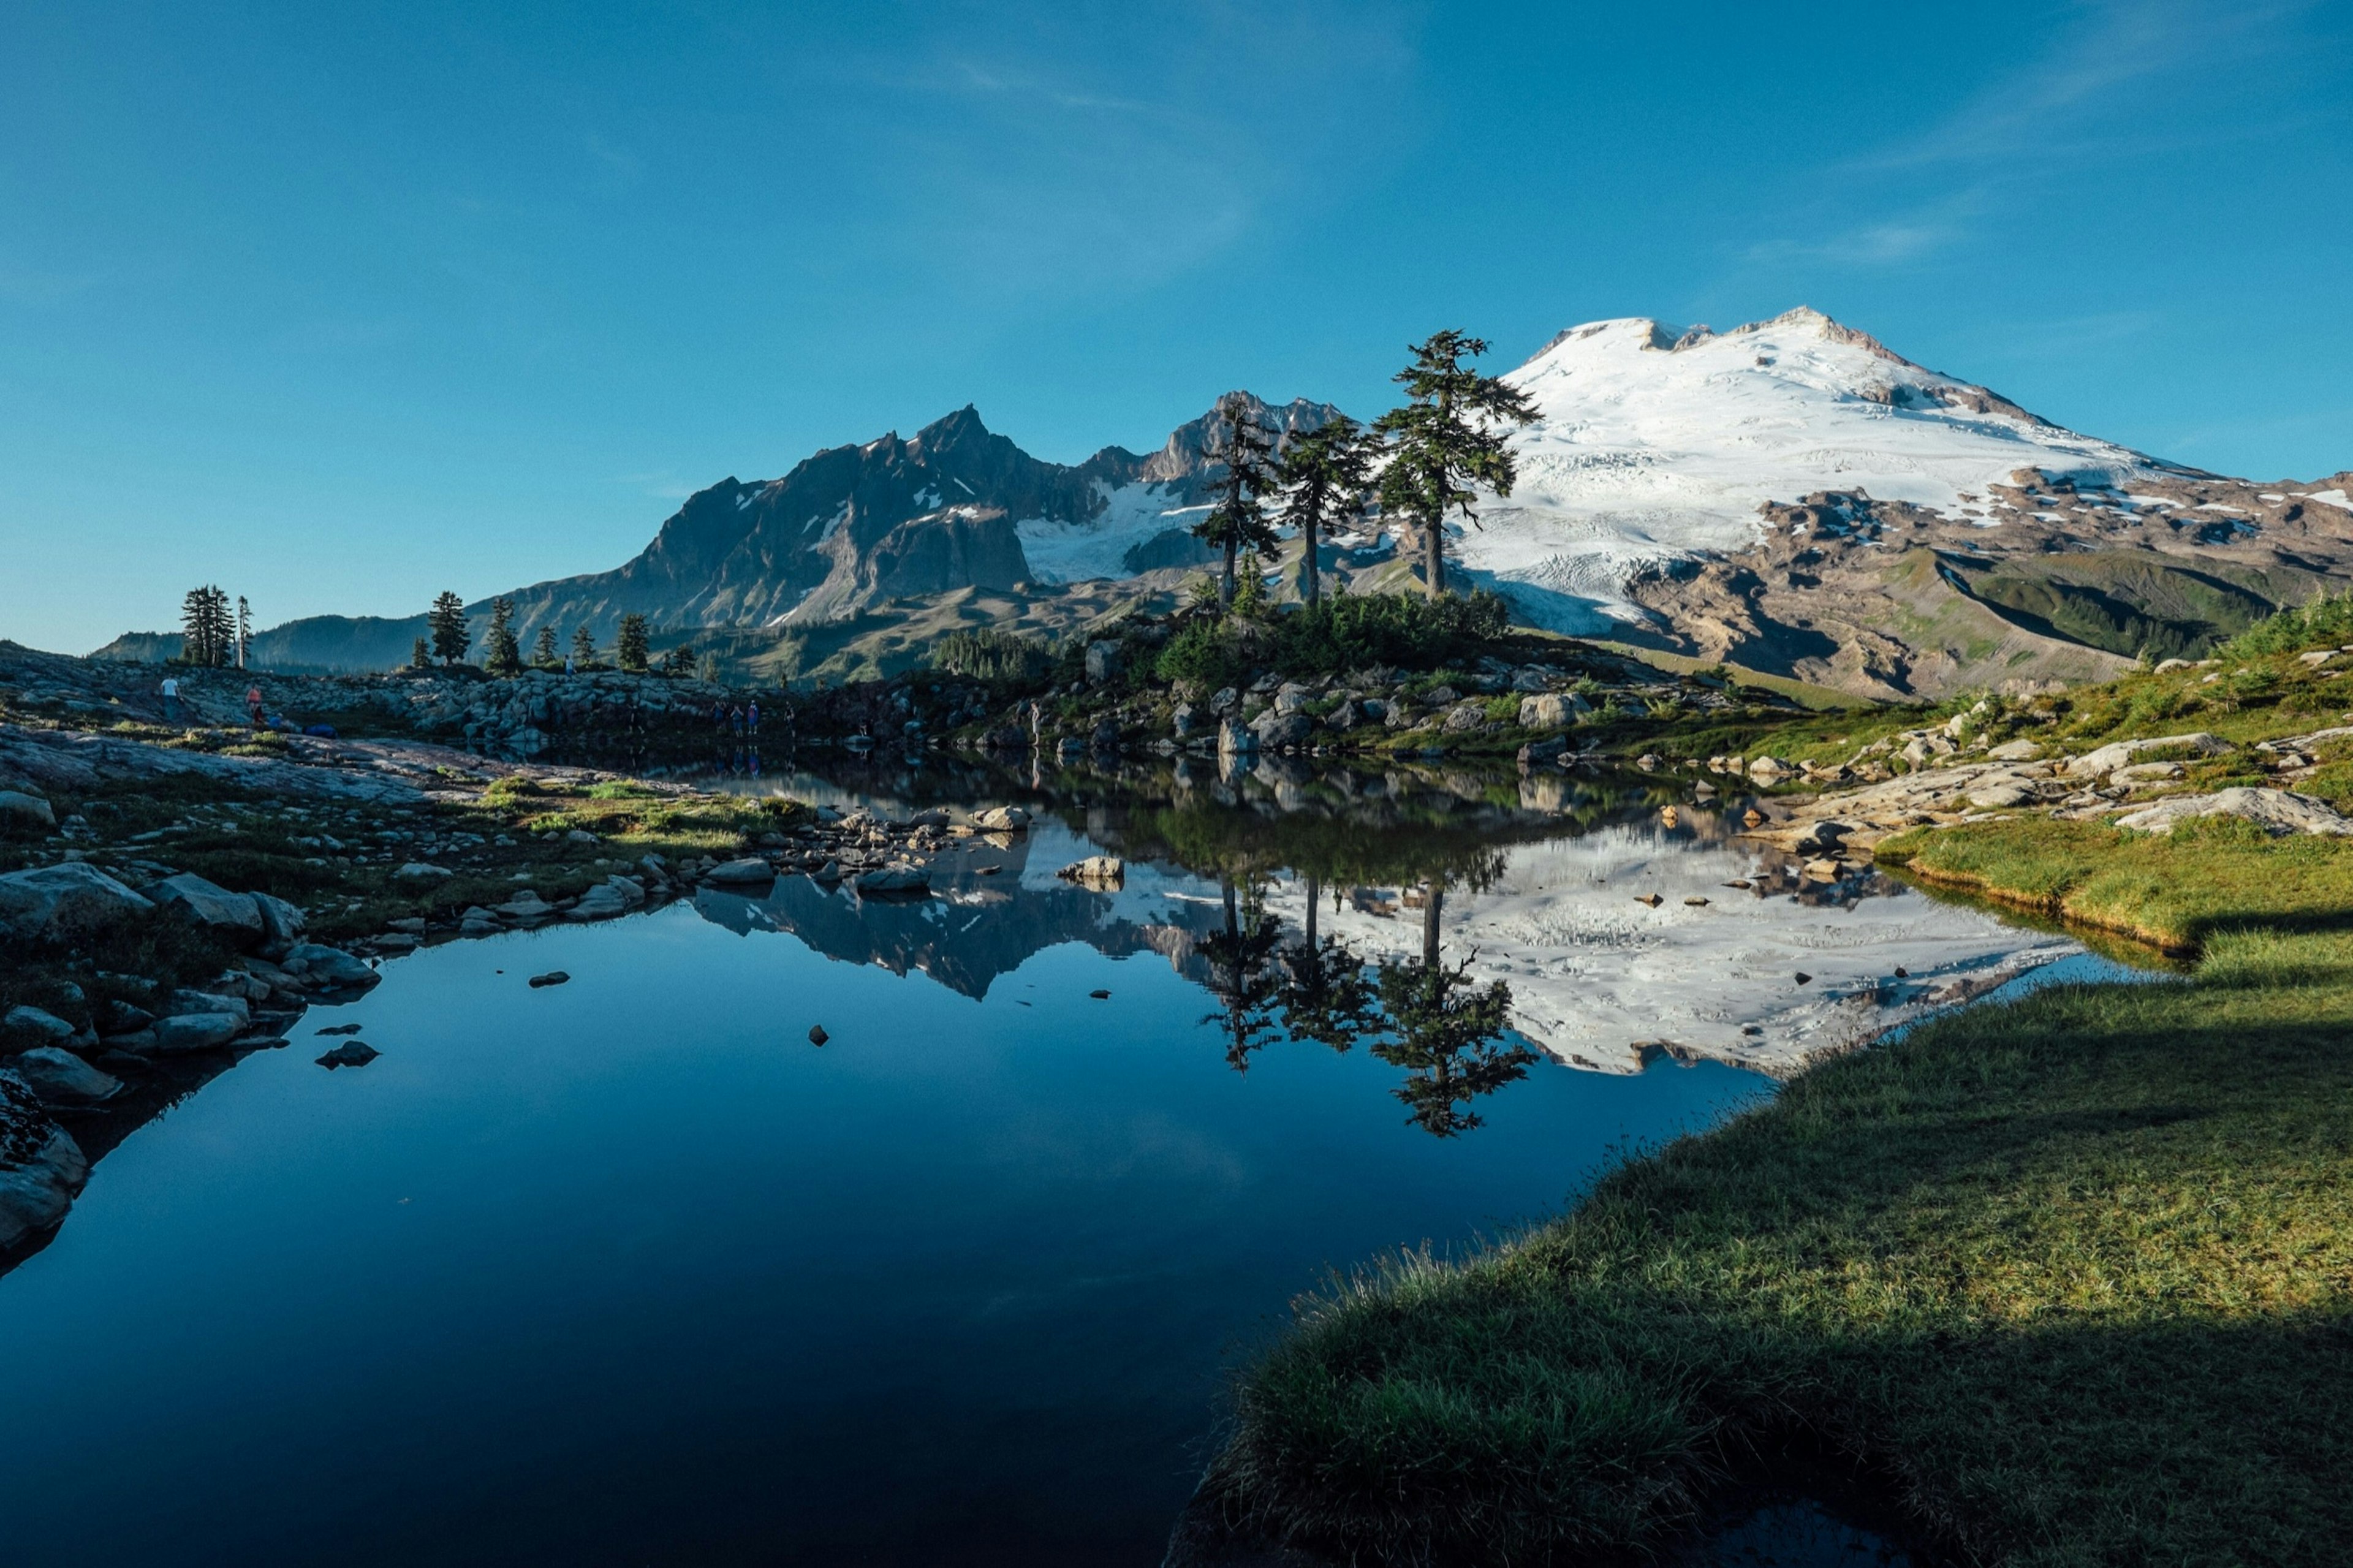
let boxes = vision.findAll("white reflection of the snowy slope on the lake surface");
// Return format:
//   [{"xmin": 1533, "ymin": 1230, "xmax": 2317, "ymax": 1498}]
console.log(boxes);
[{"xmin": 1273, "ymin": 827, "xmax": 2080, "ymax": 1071}]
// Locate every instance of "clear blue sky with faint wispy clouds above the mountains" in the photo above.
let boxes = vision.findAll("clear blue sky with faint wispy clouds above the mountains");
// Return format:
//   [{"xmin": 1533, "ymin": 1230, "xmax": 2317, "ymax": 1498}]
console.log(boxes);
[{"xmin": 0, "ymin": 0, "xmax": 2353, "ymax": 650}]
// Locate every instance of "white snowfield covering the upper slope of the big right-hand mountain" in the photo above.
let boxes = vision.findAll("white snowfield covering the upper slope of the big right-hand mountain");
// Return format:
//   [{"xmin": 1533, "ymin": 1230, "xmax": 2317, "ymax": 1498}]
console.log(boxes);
[{"xmin": 1459, "ymin": 308, "xmax": 2153, "ymax": 631}]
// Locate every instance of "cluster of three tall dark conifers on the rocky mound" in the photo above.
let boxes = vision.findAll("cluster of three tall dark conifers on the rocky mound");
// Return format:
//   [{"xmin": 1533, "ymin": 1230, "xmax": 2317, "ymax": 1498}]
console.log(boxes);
[{"xmin": 1193, "ymin": 330, "xmax": 1537, "ymax": 610}]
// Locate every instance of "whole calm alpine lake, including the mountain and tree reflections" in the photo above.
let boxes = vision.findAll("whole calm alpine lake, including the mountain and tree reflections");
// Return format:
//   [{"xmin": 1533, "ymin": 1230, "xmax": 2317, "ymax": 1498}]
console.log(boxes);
[{"xmin": 0, "ymin": 751, "xmax": 2136, "ymax": 1568}]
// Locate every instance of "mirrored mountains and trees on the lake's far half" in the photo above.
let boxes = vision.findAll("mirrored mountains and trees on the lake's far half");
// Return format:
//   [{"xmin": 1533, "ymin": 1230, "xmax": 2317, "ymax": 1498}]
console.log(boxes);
[{"xmin": 682, "ymin": 756, "xmax": 2078, "ymax": 1083}]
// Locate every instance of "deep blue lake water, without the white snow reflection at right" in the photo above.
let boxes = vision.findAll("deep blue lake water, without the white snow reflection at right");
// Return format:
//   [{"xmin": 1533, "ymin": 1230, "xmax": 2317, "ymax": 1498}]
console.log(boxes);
[{"xmin": 0, "ymin": 772, "xmax": 2061, "ymax": 1568}]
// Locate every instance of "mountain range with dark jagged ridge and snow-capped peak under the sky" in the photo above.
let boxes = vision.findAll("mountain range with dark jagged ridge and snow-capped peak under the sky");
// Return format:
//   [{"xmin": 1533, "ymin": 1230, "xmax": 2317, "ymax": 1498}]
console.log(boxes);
[{"xmin": 101, "ymin": 306, "xmax": 2353, "ymax": 697}]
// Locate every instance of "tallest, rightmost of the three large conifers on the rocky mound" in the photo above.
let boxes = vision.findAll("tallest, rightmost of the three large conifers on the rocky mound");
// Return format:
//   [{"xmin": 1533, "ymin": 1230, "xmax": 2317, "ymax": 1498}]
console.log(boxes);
[{"xmin": 1374, "ymin": 332, "xmax": 1537, "ymax": 598}]
